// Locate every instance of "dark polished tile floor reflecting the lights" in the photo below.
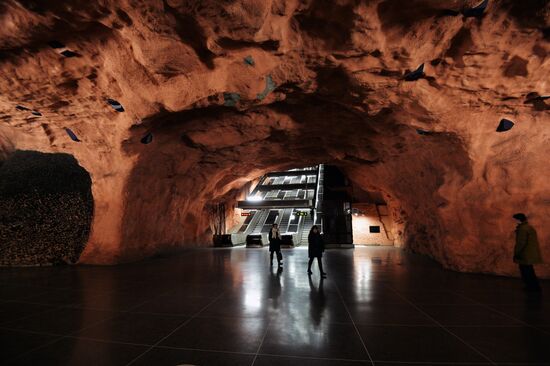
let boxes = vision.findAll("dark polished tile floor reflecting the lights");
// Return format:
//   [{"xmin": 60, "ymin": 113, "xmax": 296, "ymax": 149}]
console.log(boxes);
[{"xmin": 0, "ymin": 247, "xmax": 550, "ymax": 366}]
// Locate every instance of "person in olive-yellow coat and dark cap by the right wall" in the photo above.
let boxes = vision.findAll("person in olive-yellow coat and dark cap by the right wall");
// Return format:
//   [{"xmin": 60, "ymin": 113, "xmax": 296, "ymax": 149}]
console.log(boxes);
[{"xmin": 513, "ymin": 213, "xmax": 542, "ymax": 292}]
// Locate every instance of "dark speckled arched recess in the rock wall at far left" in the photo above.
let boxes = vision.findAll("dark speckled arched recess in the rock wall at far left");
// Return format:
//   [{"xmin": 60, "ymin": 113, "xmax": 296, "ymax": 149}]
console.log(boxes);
[{"xmin": 0, "ymin": 150, "xmax": 93, "ymax": 265}]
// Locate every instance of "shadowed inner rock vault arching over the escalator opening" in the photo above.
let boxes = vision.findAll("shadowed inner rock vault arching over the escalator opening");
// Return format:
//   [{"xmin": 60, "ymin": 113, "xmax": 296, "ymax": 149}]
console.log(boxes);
[{"xmin": 105, "ymin": 98, "xmax": 472, "ymax": 265}]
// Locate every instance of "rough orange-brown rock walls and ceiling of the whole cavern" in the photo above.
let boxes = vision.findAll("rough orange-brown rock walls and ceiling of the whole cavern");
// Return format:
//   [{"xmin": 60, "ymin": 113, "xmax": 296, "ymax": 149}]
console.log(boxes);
[{"xmin": 0, "ymin": 0, "xmax": 550, "ymax": 276}]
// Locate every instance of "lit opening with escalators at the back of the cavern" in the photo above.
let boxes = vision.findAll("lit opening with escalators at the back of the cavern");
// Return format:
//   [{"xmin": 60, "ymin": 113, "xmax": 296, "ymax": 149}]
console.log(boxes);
[{"xmin": 230, "ymin": 164, "xmax": 393, "ymax": 247}]
